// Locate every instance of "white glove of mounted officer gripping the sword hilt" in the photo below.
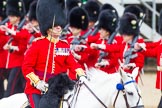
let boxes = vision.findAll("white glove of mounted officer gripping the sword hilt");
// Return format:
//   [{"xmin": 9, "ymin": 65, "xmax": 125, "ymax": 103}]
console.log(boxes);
[{"xmin": 35, "ymin": 80, "xmax": 48, "ymax": 92}]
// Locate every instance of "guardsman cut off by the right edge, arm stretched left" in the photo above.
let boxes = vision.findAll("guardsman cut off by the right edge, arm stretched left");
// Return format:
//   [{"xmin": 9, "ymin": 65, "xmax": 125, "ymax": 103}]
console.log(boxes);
[{"xmin": 138, "ymin": 10, "xmax": 162, "ymax": 108}]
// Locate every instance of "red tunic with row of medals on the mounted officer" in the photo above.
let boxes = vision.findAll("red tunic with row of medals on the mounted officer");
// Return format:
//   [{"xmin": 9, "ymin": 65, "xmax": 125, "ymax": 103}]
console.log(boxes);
[{"xmin": 22, "ymin": 38, "xmax": 80, "ymax": 94}]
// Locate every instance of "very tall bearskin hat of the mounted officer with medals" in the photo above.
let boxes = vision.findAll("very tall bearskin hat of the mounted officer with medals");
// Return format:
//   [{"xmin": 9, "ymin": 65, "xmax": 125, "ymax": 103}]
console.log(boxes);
[{"xmin": 36, "ymin": 0, "xmax": 66, "ymax": 36}]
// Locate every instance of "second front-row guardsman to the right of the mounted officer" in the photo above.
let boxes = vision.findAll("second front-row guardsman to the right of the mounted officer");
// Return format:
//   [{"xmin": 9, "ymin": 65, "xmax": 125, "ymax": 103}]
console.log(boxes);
[{"xmin": 76, "ymin": 9, "xmax": 118, "ymax": 73}]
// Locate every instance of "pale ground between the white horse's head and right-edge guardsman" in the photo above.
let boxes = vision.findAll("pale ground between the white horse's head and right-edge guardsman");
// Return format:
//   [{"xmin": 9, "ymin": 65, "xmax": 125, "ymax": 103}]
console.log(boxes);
[{"xmin": 139, "ymin": 73, "xmax": 161, "ymax": 108}]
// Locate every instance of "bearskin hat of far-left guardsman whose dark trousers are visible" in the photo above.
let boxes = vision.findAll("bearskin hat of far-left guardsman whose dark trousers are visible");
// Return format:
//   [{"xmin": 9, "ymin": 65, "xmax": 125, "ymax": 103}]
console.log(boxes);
[{"xmin": 6, "ymin": 0, "xmax": 25, "ymax": 17}]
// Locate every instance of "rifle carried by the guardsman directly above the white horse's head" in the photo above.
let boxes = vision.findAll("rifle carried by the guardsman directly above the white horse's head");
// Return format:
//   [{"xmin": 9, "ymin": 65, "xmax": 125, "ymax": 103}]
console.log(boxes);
[{"xmin": 124, "ymin": 14, "xmax": 145, "ymax": 64}]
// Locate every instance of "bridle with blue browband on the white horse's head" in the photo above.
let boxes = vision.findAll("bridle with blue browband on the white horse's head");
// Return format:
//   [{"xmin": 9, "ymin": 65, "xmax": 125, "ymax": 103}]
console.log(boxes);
[{"xmin": 113, "ymin": 76, "xmax": 144, "ymax": 108}]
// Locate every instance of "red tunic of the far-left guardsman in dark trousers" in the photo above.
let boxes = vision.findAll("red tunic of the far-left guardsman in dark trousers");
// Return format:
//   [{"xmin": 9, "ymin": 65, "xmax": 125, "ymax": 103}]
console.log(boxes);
[{"xmin": 0, "ymin": 23, "xmax": 29, "ymax": 68}]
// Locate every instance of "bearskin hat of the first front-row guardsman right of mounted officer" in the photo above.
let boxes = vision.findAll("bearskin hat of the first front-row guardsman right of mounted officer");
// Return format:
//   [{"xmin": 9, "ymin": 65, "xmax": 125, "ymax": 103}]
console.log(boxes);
[{"xmin": 68, "ymin": 7, "xmax": 88, "ymax": 30}]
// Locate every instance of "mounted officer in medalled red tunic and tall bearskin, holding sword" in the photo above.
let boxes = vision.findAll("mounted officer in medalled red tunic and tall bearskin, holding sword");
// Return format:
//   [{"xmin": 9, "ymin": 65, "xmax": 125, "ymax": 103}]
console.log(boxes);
[{"xmin": 22, "ymin": 0, "xmax": 85, "ymax": 108}]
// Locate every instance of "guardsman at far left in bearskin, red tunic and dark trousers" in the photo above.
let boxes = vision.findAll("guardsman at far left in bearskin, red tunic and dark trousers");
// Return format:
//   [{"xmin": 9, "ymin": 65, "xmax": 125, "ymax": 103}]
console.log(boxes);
[{"xmin": 0, "ymin": 0, "xmax": 29, "ymax": 96}]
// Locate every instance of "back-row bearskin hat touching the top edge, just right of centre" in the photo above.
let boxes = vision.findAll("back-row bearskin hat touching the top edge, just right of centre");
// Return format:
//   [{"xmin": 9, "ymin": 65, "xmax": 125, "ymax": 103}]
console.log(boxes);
[{"xmin": 84, "ymin": 1, "xmax": 100, "ymax": 22}]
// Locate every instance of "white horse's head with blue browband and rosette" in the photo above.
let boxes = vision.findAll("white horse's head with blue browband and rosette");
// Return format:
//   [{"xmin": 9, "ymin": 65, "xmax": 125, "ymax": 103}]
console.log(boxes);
[{"xmin": 117, "ymin": 68, "xmax": 144, "ymax": 108}]
